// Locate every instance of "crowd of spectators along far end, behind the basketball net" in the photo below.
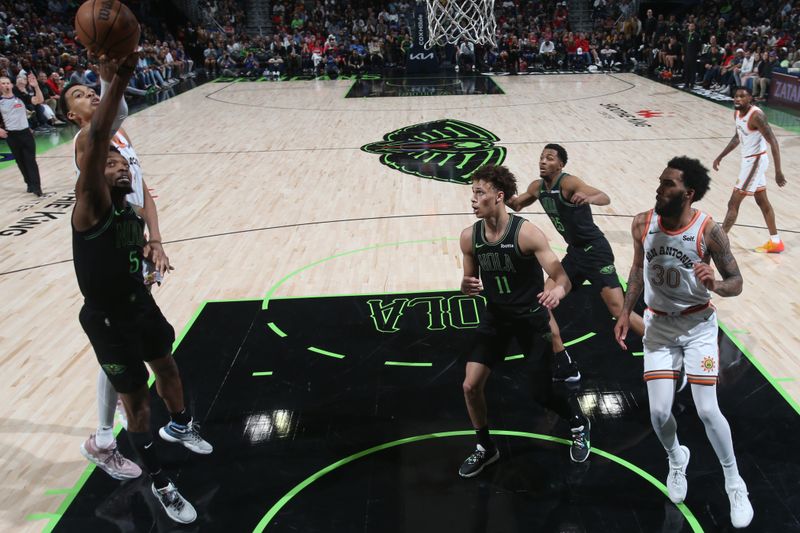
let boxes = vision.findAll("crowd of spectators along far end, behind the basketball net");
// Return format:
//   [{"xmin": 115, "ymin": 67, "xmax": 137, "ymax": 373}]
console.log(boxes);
[{"xmin": 192, "ymin": 0, "xmax": 800, "ymax": 106}]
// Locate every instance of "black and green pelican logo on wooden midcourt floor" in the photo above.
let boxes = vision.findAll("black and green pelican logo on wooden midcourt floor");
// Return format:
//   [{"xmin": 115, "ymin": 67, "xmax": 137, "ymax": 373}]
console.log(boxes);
[{"xmin": 361, "ymin": 119, "xmax": 506, "ymax": 185}]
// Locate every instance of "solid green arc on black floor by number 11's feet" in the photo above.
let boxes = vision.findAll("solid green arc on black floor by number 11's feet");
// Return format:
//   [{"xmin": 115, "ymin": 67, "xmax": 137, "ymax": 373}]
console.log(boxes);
[{"xmin": 253, "ymin": 429, "xmax": 703, "ymax": 533}]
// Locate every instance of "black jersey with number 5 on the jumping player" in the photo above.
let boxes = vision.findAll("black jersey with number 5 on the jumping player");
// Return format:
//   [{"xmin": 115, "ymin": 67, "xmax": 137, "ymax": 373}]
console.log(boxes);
[{"xmin": 72, "ymin": 206, "xmax": 152, "ymax": 316}]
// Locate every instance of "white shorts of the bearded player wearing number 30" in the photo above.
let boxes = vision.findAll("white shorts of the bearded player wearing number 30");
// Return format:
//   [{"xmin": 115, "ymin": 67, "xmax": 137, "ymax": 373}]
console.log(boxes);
[{"xmin": 643, "ymin": 307, "xmax": 719, "ymax": 385}]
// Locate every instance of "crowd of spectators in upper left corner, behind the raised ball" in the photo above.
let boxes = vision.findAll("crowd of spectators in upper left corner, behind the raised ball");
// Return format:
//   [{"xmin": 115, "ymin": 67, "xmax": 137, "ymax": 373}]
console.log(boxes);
[{"xmin": 0, "ymin": 0, "xmax": 193, "ymax": 132}]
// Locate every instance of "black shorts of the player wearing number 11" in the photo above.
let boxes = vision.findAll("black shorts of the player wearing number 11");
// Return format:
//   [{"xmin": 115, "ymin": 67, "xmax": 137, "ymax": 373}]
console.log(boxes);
[{"xmin": 467, "ymin": 304, "xmax": 553, "ymax": 368}]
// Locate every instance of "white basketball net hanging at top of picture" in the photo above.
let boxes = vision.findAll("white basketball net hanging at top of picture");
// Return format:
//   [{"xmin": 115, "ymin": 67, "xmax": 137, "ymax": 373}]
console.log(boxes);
[{"xmin": 425, "ymin": 0, "xmax": 496, "ymax": 48}]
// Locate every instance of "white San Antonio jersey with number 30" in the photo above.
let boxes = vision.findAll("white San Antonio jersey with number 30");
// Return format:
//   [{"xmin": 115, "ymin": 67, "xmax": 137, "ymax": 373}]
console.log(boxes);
[{"xmin": 642, "ymin": 209, "xmax": 711, "ymax": 315}]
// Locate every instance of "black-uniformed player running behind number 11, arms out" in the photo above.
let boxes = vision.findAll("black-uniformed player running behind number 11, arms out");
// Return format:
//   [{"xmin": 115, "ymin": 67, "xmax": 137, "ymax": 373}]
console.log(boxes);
[{"xmin": 508, "ymin": 144, "xmax": 644, "ymax": 381}]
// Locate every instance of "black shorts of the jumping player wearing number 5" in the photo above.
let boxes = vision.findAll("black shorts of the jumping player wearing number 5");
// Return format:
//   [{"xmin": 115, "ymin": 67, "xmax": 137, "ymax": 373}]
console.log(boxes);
[{"xmin": 79, "ymin": 305, "xmax": 175, "ymax": 393}]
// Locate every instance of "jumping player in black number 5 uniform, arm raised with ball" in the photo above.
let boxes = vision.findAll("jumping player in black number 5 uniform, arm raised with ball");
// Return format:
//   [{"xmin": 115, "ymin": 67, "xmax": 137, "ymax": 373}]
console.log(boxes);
[{"xmin": 67, "ymin": 53, "xmax": 212, "ymax": 523}]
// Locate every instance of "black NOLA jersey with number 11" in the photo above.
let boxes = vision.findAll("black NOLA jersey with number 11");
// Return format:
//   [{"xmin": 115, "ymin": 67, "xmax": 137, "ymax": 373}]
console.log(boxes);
[{"xmin": 472, "ymin": 215, "xmax": 544, "ymax": 313}]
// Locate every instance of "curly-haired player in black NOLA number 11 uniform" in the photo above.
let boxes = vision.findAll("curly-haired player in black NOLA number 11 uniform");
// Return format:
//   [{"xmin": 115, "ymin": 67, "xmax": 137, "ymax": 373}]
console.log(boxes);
[{"xmin": 458, "ymin": 166, "xmax": 590, "ymax": 477}]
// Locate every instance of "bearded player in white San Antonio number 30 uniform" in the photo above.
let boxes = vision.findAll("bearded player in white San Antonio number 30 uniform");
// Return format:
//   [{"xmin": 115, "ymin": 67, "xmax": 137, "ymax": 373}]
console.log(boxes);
[{"xmin": 614, "ymin": 157, "xmax": 753, "ymax": 527}]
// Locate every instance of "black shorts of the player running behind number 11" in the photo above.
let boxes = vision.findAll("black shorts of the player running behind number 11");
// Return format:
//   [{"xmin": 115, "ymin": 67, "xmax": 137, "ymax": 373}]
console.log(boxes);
[{"xmin": 561, "ymin": 237, "xmax": 621, "ymax": 291}]
